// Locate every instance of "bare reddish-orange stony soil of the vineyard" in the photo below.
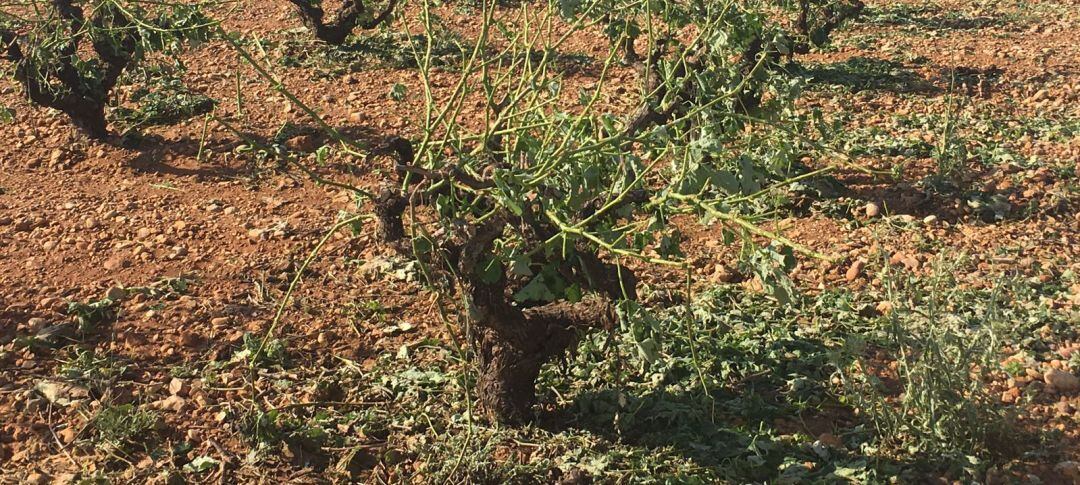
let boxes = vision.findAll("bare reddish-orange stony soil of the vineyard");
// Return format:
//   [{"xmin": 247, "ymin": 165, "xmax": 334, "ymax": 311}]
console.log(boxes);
[{"xmin": 0, "ymin": 0, "xmax": 1080, "ymax": 483}]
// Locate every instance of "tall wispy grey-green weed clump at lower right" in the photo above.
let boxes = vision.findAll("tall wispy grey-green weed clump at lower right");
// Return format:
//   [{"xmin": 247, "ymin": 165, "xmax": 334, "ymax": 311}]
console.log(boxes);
[{"xmin": 841, "ymin": 252, "xmax": 1018, "ymax": 458}]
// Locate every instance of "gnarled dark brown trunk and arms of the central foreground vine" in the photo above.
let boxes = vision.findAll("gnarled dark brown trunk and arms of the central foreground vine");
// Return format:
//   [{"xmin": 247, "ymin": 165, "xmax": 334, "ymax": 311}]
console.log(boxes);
[{"xmin": 375, "ymin": 138, "xmax": 637, "ymax": 423}]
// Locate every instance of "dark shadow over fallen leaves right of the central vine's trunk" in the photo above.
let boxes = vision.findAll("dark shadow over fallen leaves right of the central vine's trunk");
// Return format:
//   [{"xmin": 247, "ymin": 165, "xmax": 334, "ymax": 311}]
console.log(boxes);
[{"xmin": 540, "ymin": 306, "xmax": 903, "ymax": 482}]
